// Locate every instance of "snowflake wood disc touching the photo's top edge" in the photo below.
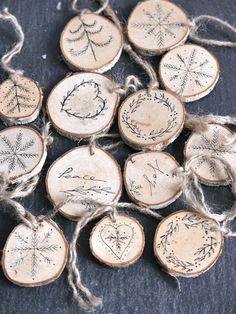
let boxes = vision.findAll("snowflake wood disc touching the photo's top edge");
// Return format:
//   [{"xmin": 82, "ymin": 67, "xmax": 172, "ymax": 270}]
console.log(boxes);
[{"xmin": 127, "ymin": 0, "xmax": 189, "ymax": 55}]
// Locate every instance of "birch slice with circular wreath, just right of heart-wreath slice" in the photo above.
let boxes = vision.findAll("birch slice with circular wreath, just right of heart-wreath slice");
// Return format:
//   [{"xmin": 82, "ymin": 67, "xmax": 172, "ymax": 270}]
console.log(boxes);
[{"xmin": 118, "ymin": 89, "xmax": 185, "ymax": 150}]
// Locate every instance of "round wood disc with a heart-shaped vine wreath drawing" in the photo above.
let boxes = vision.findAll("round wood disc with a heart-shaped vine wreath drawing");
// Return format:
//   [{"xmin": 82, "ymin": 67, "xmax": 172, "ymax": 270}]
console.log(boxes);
[{"xmin": 47, "ymin": 73, "xmax": 119, "ymax": 139}]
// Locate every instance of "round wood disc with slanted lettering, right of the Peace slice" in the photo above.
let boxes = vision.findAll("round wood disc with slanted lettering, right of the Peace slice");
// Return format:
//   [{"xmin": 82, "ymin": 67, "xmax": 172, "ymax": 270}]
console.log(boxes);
[{"xmin": 124, "ymin": 151, "xmax": 182, "ymax": 209}]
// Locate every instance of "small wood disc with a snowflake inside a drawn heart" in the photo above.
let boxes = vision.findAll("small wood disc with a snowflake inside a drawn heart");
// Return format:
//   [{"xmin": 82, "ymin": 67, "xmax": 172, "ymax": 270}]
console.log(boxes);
[{"xmin": 89, "ymin": 214, "xmax": 145, "ymax": 267}]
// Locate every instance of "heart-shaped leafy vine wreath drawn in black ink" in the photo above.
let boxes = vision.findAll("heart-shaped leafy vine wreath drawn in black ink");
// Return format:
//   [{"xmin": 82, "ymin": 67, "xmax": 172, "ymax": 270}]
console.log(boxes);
[{"xmin": 60, "ymin": 80, "xmax": 108, "ymax": 120}]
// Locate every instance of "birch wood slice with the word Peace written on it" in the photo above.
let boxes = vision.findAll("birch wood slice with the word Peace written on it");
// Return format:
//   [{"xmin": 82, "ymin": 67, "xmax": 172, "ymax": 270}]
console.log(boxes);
[{"xmin": 46, "ymin": 145, "xmax": 122, "ymax": 220}]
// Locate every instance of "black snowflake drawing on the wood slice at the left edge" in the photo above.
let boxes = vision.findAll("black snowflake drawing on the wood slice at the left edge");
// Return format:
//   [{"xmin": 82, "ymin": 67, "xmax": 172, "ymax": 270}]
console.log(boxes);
[{"xmin": 0, "ymin": 130, "xmax": 38, "ymax": 173}]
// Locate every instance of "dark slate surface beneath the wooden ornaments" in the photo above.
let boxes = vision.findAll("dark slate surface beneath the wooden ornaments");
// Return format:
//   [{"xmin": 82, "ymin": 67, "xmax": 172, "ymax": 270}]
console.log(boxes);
[{"xmin": 0, "ymin": 0, "xmax": 236, "ymax": 314}]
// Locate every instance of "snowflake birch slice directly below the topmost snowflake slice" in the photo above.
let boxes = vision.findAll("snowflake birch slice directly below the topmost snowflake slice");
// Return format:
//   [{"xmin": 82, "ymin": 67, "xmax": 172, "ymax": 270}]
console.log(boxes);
[{"xmin": 159, "ymin": 44, "xmax": 220, "ymax": 102}]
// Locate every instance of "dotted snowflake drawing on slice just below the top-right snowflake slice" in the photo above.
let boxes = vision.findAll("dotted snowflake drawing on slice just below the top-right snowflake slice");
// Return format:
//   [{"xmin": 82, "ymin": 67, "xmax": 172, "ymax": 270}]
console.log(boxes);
[{"xmin": 163, "ymin": 48, "xmax": 212, "ymax": 94}]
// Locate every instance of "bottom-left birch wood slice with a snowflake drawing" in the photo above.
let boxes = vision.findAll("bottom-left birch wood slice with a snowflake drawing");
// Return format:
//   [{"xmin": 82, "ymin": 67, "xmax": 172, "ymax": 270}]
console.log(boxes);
[{"xmin": 2, "ymin": 220, "xmax": 68, "ymax": 287}]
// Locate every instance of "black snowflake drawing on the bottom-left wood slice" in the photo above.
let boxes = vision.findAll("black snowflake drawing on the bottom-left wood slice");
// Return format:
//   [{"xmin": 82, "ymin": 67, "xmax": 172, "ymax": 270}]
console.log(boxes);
[{"xmin": 8, "ymin": 230, "xmax": 61, "ymax": 280}]
